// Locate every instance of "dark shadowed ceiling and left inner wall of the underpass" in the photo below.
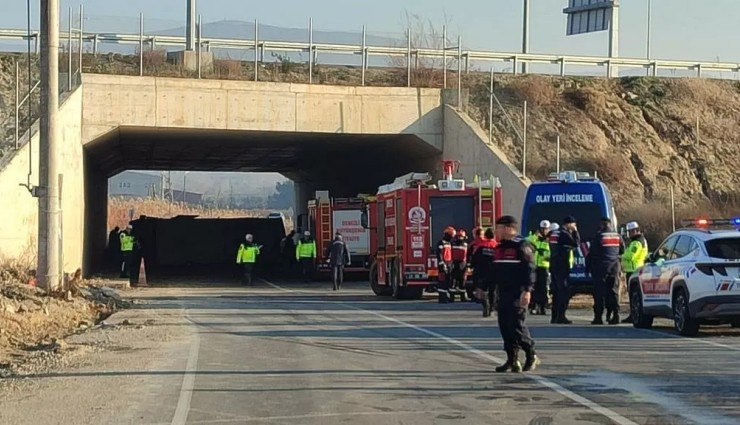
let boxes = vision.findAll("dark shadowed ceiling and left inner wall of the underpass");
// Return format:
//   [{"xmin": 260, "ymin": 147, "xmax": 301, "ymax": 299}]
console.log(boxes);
[{"xmin": 83, "ymin": 127, "xmax": 441, "ymax": 274}]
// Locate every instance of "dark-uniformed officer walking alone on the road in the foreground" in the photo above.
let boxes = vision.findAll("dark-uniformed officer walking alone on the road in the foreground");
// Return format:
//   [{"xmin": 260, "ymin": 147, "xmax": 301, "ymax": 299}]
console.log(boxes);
[{"xmin": 491, "ymin": 215, "xmax": 540, "ymax": 372}]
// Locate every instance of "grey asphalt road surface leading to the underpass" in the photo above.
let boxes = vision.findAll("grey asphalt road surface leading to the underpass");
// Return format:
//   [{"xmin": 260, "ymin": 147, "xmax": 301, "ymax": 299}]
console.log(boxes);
[{"xmin": 0, "ymin": 281, "xmax": 740, "ymax": 425}]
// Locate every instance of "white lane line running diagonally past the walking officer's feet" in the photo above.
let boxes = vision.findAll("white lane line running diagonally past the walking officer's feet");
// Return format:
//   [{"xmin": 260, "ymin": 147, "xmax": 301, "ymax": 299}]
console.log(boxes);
[{"xmin": 264, "ymin": 280, "xmax": 637, "ymax": 425}]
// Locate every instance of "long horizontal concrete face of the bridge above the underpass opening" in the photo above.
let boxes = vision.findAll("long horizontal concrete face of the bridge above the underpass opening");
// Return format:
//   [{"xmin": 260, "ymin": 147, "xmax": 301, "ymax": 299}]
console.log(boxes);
[{"xmin": 83, "ymin": 74, "xmax": 443, "ymax": 149}]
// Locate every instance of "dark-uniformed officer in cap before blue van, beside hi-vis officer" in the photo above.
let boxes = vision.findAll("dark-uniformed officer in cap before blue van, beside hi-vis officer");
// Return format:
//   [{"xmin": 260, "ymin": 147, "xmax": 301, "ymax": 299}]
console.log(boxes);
[{"xmin": 550, "ymin": 216, "xmax": 581, "ymax": 325}]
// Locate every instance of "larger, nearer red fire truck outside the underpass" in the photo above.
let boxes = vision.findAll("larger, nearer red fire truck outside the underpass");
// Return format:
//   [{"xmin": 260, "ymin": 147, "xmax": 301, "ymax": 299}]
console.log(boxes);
[{"xmin": 362, "ymin": 161, "xmax": 502, "ymax": 299}]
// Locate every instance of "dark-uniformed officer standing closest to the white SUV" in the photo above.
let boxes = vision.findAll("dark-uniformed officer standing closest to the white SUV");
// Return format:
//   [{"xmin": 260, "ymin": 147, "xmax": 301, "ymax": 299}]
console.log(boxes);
[{"xmin": 586, "ymin": 217, "xmax": 624, "ymax": 325}]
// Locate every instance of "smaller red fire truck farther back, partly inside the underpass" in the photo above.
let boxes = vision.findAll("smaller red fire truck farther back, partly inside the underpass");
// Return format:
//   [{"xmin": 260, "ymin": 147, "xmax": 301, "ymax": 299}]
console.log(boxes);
[{"xmin": 308, "ymin": 191, "xmax": 370, "ymax": 273}]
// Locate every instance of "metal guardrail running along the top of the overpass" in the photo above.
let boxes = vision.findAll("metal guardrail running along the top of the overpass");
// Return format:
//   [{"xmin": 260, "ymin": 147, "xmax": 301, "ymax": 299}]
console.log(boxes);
[{"xmin": 0, "ymin": 22, "xmax": 740, "ymax": 77}]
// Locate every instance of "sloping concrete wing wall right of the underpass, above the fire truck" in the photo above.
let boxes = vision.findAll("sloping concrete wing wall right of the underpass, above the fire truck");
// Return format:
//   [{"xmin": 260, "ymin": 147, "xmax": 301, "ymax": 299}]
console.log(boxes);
[{"xmin": 443, "ymin": 105, "xmax": 530, "ymax": 219}]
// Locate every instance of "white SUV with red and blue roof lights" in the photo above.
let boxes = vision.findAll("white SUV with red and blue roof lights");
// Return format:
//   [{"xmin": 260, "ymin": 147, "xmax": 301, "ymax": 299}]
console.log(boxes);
[{"xmin": 628, "ymin": 218, "xmax": 740, "ymax": 336}]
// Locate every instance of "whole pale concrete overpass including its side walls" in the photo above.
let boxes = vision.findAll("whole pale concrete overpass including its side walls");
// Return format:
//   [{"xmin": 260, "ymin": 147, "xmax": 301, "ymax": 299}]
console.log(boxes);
[{"xmin": 0, "ymin": 74, "xmax": 527, "ymax": 273}]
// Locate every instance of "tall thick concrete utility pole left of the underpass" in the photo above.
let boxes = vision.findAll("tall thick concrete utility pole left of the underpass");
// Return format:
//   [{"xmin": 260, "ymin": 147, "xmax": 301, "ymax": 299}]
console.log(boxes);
[{"xmin": 36, "ymin": 0, "xmax": 61, "ymax": 290}]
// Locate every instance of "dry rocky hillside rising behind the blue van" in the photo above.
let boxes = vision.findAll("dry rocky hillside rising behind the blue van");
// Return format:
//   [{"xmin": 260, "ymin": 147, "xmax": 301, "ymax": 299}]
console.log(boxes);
[{"xmin": 469, "ymin": 76, "xmax": 740, "ymax": 225}]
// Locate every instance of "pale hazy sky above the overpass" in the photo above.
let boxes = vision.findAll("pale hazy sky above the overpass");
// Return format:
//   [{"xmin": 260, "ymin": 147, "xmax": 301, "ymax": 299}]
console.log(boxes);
[{"xmin": 0, "ymin": 0, "xmax": 740, "ymax": 62}]
